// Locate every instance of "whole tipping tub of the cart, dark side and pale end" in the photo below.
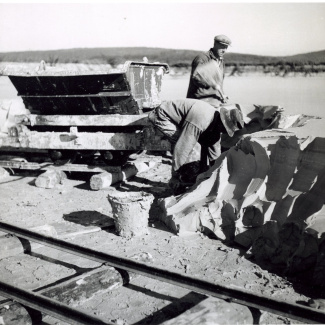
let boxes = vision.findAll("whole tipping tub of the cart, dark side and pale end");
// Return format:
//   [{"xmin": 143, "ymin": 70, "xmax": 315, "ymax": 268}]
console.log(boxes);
[{"xmin": 8, "ymin": 61, "xmax": 169, "ymax": 115}]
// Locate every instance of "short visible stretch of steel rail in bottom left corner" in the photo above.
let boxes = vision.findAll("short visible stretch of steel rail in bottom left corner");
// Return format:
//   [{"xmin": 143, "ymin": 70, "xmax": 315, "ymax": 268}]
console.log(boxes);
[{"xmin": 0, "ymin": 282, "xmax": 115, "ymax": 325}]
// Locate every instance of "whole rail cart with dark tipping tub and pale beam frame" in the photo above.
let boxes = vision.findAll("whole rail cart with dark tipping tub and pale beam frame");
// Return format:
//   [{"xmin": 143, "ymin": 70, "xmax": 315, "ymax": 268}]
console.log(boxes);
[{"xmin": 0, "ymin": 61, "xmax": 170, "ymax": 165}]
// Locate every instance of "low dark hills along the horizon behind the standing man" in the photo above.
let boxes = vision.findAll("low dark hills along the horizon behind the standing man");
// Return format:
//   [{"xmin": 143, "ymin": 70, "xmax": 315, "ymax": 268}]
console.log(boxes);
[{"xmin": 0, "ymin": 47, "xmax": 325, "ymax": 67}]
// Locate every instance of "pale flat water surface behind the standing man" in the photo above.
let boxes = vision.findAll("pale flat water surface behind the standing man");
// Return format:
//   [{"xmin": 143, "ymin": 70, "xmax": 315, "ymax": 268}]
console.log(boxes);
[{"xmin": 161, "ymin": 74, "xmax": 325, "ymax": 117}]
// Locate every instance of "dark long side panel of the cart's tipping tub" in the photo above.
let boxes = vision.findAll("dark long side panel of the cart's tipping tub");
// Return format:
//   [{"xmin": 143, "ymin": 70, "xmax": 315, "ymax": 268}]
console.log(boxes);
[{"xmin": 9, "ymin": 73, "xmax": 139, "ymax": 115}]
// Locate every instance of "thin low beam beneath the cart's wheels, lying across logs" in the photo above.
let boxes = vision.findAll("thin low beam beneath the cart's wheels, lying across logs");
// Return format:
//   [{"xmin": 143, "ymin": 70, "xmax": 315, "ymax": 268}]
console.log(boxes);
[{"xmin": 0, "ymin": 157, "xmax": 121, "ymax": 173}]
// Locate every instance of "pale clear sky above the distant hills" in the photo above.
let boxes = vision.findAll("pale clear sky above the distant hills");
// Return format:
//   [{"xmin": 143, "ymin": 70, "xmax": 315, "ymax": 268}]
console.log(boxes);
[{"xmin": 0, "ymin": 0, "xmax": 325, "ymax": 56}]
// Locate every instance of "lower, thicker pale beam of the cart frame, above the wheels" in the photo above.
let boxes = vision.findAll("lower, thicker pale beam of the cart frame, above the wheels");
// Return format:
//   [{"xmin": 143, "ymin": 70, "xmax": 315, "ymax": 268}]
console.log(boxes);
[{"xmin": 0, "ymin": 129, "xmax": 171, "ymax": 151}]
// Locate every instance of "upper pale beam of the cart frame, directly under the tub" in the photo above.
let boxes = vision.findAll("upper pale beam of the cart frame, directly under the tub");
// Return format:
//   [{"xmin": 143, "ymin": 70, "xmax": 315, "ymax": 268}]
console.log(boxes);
[{"xmin": 15, "ymin": 114, "xmax": 150, "ymax": 126}]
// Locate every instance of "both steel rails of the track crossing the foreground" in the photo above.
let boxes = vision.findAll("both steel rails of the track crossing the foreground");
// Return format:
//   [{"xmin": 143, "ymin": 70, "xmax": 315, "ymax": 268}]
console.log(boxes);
[{"xmin": 0, "ymin": 222, "xmax": 325, "ymax": 324}]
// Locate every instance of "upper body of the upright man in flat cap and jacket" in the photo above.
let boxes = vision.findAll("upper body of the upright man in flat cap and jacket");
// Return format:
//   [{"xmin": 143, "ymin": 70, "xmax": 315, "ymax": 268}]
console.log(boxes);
[{"xmin": 186, "ymin": 35, "xmax": 231, "ymax": 108}]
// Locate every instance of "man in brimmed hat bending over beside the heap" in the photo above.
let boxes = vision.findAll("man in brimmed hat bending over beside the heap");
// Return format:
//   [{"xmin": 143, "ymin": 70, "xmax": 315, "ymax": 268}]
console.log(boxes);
[{"xmin": 148, "ymin": 99, "xmax": 244, "ymax": 194}]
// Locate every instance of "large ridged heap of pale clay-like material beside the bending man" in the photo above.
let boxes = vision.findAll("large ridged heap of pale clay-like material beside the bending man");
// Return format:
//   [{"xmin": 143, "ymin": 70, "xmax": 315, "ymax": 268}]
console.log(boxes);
[{"xmin": 161, "ymin": 107, "xmax": 325, "ymax": 283}]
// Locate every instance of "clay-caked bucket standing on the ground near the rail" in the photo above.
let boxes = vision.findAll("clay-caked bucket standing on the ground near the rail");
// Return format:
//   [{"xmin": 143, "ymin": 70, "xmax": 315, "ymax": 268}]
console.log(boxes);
[{"xmin": 108, "ymin": 192, "xmax": 154, "ymax": 238}]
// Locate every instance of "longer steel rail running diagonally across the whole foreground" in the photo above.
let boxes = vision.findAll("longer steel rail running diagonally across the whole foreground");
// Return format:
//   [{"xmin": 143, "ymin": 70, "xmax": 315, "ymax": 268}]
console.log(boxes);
[{"xmin": 0, "ymin": 222, "xmax": 325, "ymax": 324}]
